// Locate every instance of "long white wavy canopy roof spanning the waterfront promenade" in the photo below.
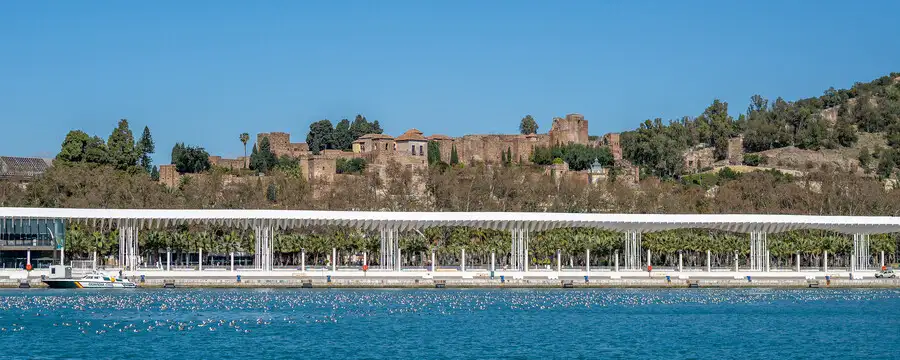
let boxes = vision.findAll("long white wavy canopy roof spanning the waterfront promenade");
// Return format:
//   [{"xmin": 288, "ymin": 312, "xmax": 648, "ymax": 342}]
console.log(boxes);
[{"xmin": 0, "ymin": 208, "xmax": 900, "ymax": 234}]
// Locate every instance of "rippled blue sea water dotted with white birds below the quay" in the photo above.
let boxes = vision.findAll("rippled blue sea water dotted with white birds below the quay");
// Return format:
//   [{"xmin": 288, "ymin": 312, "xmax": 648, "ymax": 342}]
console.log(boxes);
[{"xmin": 0, "ymin": 289, "xmax": 900, "ymax": 360}]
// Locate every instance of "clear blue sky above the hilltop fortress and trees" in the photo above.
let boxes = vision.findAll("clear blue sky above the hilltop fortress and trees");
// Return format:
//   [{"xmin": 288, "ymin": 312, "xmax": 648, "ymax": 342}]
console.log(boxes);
[{"xmin": 0, "ymin": 0, "xmax": 900, "ymax": 163}]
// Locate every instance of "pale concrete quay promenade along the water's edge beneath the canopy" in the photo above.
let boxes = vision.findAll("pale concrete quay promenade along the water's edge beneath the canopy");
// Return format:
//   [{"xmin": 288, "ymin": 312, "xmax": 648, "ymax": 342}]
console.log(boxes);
[{"xmin": 0, "ymin": 268, "xmax": 900, "ymax": 288}]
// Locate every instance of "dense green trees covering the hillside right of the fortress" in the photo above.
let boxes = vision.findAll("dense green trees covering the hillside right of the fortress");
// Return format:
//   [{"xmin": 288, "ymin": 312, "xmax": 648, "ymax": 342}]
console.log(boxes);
[{"xmin": 622, "ymin": 73, "xmax": 900, "ymax": 178}]
